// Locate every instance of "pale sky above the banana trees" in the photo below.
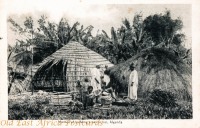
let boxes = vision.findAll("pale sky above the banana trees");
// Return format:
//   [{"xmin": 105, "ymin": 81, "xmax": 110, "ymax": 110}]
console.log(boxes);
[{"xmin": 7, "ymin": 1, "xmax": 192, "ymax": 47}]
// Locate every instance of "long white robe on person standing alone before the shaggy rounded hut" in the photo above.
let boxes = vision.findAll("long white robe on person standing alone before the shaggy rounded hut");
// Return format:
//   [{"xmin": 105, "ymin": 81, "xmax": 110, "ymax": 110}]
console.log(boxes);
[{"xmin": 128, "ymin": 70, "xmax": 138, "ymax": 100}]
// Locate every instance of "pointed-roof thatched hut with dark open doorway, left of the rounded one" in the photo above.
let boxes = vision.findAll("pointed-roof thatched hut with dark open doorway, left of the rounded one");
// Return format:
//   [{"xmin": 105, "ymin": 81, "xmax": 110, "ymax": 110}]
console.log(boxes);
[{"xmin": 31, "ymin": 41, "xmax": 113, "ymax": 91}]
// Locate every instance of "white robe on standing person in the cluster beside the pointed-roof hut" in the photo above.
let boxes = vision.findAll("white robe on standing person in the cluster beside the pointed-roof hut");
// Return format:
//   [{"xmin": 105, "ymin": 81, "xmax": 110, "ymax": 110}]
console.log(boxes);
[{"xmin": 91, "ymin": 68, "xmax": 101, "ymax": 96}]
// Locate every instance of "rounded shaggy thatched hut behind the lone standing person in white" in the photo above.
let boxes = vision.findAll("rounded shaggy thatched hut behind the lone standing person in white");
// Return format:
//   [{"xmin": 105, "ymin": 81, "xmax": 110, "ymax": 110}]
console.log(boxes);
[{"xmin": 108, "ymin": 48, "xmax": 192, "ymax": 100}]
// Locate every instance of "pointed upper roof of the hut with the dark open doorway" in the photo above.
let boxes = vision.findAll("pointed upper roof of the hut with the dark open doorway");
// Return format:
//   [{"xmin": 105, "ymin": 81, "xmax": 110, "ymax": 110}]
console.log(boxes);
[{"xmin": 32, "ymin": 41, "xmax": 113, "ymax": 70}]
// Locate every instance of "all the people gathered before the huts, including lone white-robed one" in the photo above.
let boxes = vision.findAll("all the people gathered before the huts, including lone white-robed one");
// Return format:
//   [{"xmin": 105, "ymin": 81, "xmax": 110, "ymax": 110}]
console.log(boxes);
[{"xmin": 77, "ymin": 64, "xmax": 138, "ymax": 109}]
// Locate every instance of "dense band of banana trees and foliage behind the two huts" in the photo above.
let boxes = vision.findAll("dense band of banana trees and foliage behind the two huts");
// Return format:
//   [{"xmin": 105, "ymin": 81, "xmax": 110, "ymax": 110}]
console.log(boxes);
[{"xmin": 8, "ymin": 11, "xmax": 191, "ymax": 65}]
